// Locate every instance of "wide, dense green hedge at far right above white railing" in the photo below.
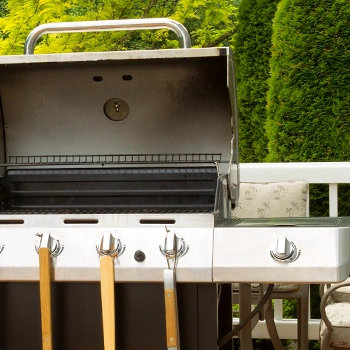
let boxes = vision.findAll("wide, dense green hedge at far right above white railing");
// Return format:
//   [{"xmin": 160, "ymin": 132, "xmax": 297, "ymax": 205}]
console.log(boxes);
[{"xmin": 267, "ymin": 0, "xmax": 350, "ymax": 162}]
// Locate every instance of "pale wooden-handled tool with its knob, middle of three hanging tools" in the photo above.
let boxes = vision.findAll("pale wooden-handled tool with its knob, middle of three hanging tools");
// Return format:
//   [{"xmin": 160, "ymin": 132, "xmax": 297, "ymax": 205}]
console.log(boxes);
[{"xmin": 96, "ymin": 233, "xmax": 125, "ymax": 350}]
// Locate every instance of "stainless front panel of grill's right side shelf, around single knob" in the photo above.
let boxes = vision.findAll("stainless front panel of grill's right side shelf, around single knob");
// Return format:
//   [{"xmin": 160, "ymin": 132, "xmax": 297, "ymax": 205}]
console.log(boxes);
[{"xmin": 213, "ymin": 226, "xmax": 350, "ymax": 283}]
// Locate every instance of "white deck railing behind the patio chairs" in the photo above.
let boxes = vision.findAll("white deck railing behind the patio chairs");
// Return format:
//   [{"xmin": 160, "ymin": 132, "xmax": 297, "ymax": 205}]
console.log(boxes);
[{"xmin": 240, "ymin": 162, "xmax": 350, "ymax": 340}]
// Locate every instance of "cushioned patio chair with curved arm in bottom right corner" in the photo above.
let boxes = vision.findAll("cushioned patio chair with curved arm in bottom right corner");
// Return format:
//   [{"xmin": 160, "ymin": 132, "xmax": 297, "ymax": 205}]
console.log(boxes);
[{"xmin": 320, "ymin": 279, "xmax": 350, "ymax": 350}]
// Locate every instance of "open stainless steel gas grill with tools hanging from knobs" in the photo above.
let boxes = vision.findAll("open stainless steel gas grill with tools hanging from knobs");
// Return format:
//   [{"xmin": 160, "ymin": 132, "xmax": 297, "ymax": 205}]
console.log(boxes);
[{"xmin": 0, "ymin": 19, "xmax": 350, "ymax": 350}]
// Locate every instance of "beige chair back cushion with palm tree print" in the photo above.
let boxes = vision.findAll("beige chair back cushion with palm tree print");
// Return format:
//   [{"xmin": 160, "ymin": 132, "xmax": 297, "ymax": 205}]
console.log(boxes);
[{"xmin": 232, "ymin": 180, "xmax": 308, "ymax": 218}]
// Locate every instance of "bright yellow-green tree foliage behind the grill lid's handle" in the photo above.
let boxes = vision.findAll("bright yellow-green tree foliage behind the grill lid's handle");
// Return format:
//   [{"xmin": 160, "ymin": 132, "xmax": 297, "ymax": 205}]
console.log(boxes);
[{"xmin": 0, "ymin": 0, "xmax": 236, "ymax": 55}]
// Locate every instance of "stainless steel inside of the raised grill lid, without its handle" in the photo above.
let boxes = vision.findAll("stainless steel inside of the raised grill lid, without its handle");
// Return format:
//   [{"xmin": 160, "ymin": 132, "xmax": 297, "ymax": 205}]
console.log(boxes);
[{"xmin": 0, "ymin": 48, "xmax": 238, "ymax": 180}]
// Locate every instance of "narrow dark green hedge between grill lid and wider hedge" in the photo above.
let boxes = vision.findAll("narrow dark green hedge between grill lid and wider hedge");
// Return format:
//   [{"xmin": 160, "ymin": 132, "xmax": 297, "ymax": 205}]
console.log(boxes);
[{"xmin": 234, "ymin": 0, "xmax": 278, "ymax": 162}]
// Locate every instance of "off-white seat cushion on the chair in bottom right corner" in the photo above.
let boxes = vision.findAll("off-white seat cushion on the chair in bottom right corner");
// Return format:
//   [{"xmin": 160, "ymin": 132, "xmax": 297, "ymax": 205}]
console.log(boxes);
[{"xmin": 320, "ymin": 303, "xmax": 350, "ymax": 348}]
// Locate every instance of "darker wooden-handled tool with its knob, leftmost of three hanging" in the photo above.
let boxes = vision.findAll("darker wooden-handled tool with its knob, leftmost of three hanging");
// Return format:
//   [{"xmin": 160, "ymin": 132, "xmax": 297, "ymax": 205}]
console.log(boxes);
[{"xmin": 35, "ymin": 233, "xmax": 63, "ymax": 350}]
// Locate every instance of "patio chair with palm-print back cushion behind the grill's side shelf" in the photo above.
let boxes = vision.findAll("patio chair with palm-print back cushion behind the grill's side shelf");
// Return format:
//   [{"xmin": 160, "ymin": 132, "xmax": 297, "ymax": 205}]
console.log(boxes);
[{"xmin": 233, "ymin": 180, "xmax": 309, "ymax": 350}]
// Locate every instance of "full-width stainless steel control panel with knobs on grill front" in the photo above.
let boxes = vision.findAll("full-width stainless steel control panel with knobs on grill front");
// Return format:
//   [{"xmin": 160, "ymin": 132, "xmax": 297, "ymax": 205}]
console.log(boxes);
[{"xmin": 0, "ymin": 213, "xmax": 350, "ymax": 283}]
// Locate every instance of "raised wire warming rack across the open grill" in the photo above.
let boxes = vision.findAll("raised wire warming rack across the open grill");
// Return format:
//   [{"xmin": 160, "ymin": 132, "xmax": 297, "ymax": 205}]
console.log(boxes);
[{"xmin": 6, "ymin": 153, "xmax": 222, "ymax": 166}]
